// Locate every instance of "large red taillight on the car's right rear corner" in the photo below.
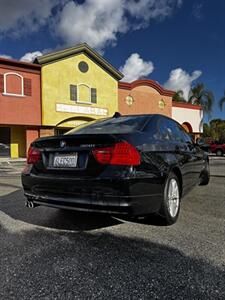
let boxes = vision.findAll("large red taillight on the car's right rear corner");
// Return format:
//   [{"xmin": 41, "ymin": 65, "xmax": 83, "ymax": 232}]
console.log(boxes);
[{"xmin": 92, "ymin": 142, "xmax": 140, "ymax": 166}]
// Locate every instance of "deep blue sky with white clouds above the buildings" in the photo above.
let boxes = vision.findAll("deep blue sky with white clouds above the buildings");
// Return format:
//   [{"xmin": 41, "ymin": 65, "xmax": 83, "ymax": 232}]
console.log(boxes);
[{"xmin": 0, "ymin": 0, "xmax": 225, "ymax": 121}]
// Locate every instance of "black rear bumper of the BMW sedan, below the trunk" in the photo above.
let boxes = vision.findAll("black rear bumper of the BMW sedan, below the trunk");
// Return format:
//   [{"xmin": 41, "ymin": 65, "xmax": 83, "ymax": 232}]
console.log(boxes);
[{"xmin": 22, "ymin": 174, "xmax": 163, "ymax": 215}]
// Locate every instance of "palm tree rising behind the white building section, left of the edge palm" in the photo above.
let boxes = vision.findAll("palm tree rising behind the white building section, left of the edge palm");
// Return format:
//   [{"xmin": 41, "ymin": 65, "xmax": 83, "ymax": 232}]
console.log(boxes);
[{"xmin": 188, "ymin": 83, "xmax": 214, "ymax": 116}]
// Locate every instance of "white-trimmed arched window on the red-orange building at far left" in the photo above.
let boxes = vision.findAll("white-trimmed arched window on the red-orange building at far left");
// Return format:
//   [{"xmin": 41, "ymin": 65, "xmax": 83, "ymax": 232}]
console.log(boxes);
[{"xmin": 3, "ymin": 72, "xmax": 24, "ymax": 97}]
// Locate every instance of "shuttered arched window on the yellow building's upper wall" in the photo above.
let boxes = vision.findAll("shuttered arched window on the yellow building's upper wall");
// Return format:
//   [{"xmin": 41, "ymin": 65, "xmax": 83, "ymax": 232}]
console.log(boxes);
[{"xmin": 70, "ymin": 83, "xmax": 97, "ymax": 104}]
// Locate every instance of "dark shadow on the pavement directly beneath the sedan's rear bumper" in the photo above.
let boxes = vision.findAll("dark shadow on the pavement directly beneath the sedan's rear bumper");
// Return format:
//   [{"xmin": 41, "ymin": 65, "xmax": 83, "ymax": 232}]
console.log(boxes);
[{"xmin": 0, "ymin": 189, "xmax": 121, "ymax": 231}]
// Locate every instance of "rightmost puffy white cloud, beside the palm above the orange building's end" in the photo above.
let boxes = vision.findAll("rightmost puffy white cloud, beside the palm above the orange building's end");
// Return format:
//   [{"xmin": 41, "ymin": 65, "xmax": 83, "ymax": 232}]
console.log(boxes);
[{"xmin": 164, "ymin": 68, "xmax": 202, "ymax": 100}]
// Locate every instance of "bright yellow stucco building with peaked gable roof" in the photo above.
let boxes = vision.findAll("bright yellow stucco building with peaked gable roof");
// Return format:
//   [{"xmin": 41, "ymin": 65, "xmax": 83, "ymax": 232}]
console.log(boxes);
[{"xmin": 36, "ymin": 44, "xmax": 123, "ymax": 136}]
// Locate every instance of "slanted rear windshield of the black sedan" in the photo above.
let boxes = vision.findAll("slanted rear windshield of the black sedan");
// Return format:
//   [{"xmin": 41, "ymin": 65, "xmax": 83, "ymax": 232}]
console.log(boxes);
[{"xmin": 66, "ymin": 116, "xmax": 149, "ymax": 134}]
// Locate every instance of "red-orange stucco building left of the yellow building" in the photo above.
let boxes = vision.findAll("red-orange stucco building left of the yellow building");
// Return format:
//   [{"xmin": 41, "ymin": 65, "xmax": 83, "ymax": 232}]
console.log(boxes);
[{"xmin": 0, "ymin": 58, "xmax": 41, "ymax": 157}]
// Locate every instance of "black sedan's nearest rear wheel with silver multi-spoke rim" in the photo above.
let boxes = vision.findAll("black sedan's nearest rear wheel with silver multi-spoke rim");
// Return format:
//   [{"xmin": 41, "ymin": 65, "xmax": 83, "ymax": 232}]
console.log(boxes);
[{"xmin": 159, "ymin": 172, "xmax": 181, "ymax": 225}]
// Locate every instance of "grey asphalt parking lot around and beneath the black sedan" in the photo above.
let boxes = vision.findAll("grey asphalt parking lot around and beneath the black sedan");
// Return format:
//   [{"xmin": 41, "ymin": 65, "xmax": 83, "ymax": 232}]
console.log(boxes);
[{"xmin": 0, "ymin": 158, "xmax": 225, "ymax": 299}]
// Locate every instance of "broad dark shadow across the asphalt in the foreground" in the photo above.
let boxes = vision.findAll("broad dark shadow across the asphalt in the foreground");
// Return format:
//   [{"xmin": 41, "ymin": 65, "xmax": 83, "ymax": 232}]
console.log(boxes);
[{"xmin": 0, "ymin": 223, "xmax": 225, "ymax": 299}]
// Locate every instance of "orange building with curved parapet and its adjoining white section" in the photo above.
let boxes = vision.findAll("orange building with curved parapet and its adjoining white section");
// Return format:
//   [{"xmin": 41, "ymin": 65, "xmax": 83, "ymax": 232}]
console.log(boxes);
[{"xmin": 118, "ymin": 79, "xmax": 203, "ymax": 137}]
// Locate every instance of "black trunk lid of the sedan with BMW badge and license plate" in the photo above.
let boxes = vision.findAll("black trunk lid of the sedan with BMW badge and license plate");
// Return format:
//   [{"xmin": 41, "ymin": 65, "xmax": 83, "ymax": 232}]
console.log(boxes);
[{"xmin": 32, "ymin": 134, "xmax": 121, "ymax": 177}]
